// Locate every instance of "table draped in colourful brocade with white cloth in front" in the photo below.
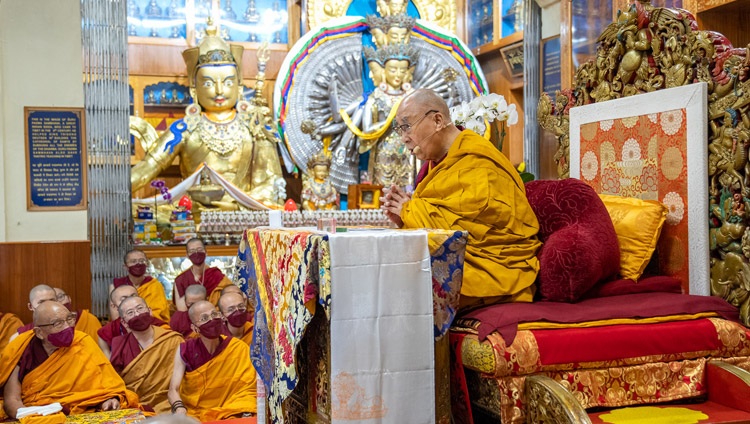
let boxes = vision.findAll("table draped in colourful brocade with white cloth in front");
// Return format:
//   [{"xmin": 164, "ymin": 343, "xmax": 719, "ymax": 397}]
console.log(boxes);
[{"xmin": 237, "ymin": 228, "xmax": 467, "ymax": 423}]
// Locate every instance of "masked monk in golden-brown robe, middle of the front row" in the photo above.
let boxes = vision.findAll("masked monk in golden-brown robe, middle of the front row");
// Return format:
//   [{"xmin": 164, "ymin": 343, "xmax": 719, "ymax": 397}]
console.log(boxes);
[{"xmin": 110, "ymin": 296, "xmax": 184, "ymax": 413}]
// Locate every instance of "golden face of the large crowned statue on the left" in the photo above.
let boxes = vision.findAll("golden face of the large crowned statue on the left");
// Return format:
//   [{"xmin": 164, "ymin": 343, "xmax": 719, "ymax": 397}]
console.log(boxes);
[{"xmin": 195, "ymin": 65, "xmax": 239, "ymax": 112}]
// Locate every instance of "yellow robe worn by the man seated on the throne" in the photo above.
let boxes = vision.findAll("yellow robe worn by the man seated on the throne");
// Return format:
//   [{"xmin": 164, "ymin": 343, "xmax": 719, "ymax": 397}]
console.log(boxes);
[{"xmin": 401, "ymin": 131, "xmax": 541, "ymax": 302}]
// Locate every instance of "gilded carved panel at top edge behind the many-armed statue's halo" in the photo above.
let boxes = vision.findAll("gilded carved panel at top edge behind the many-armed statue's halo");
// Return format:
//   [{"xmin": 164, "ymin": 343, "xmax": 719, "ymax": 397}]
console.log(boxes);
[{"xmin": 307, "ymin": 0, "xmax": 458, "ymax": 34}]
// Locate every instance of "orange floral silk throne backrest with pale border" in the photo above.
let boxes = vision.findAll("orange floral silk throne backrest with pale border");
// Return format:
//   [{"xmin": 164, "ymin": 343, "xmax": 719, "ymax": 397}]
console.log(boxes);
[{"xmin": 570, "ymin": 83, "xmax": 710, "ymax": 295}]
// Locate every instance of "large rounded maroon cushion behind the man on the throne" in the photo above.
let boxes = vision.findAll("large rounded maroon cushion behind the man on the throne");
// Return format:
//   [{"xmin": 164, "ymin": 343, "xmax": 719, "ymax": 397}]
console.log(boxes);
[{"xmin": 526, "ymin": 178, "xmax": 620, "ymax": 302}]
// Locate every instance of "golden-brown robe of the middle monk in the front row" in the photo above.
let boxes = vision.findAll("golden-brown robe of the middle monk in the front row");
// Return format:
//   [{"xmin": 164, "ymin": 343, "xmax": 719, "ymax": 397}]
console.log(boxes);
[{"xmin": 121, "ymin": 326, "xmax": 184, "ymax": 414}]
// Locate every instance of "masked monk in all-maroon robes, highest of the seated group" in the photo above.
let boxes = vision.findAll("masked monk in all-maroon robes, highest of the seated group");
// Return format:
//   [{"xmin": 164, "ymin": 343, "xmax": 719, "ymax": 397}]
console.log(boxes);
[{"xmin": 174, "ymin": 238, "xmax": 232, "ymax": 311}]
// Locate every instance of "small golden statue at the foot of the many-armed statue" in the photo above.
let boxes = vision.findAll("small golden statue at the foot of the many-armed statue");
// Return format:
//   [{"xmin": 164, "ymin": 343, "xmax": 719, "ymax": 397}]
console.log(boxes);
[{"xmin": 302, "ymin": 148, "xmax": 338, "ymax": 211}]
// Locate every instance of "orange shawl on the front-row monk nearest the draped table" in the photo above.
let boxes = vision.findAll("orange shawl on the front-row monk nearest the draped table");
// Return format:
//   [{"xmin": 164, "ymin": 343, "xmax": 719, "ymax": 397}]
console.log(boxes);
[{"xmin": 180, "ymin": 337, "xmax": 256, "ymax": 422}]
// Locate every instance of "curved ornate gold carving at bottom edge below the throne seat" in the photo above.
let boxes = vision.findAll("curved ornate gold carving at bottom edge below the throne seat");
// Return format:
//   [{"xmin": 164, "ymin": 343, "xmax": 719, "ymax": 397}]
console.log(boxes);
[{"xmin": 525, "ymin": 375, "xmax": 591, "ymax": 424}]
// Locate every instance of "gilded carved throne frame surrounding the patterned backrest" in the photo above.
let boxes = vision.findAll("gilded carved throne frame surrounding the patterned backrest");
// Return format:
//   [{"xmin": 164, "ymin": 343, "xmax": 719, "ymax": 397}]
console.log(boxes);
[{"xmin": 537, "ymin": 0, "xmax": 750, "ymax": 325}]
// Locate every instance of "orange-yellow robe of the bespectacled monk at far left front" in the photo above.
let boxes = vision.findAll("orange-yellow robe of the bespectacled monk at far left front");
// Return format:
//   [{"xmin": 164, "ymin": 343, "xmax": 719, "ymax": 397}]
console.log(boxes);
[{"xmin": 0, "ymin": 331, "xmax": 139, "ymax": 418}]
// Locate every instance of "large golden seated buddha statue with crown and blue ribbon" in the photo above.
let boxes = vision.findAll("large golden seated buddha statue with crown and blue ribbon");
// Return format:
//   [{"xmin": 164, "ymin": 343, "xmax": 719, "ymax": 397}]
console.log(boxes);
[{"xmin": 130, "ymin": 20, "xmax": 285, "ymax": 210}]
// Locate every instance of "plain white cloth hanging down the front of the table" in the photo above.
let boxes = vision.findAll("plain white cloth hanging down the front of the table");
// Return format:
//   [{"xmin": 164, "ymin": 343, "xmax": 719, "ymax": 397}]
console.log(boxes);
[{"xmin": 329, "ymin": 230, "xmax": 435, "ymax": 424}]
